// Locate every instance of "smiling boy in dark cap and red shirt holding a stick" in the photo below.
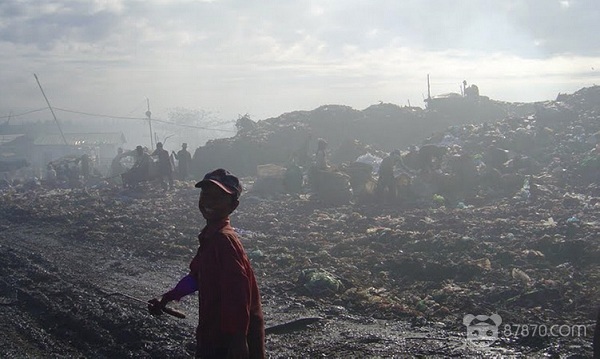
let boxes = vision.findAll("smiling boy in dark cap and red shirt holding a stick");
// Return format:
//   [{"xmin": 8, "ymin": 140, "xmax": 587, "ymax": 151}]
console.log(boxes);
[{"xmin": 148, "ymin": 169, "xmax": 265, "ymax": 359}]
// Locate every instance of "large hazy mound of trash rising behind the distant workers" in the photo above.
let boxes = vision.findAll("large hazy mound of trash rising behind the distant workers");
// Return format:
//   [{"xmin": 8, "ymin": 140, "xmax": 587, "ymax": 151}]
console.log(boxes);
[{"xmin": 192, "ymin": 97, "xmax": 533, "ymax": 176}]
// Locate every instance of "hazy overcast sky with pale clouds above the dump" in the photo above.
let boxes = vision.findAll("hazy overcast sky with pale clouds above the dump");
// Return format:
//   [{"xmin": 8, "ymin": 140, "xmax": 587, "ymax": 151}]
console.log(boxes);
[{"xmin": 0, "ymin": 0, "xmax": 600, "ymax": 126}]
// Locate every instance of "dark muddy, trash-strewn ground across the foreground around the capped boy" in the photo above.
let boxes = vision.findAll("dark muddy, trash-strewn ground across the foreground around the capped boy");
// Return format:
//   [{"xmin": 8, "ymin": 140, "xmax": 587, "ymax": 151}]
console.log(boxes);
[{"xmin": 0, "ymin": 182, "xmax": 600, "ymax": 358}]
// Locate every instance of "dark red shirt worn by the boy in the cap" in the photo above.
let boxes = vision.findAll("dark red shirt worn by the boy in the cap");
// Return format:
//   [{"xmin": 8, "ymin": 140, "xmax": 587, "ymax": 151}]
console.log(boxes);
[{"xmin": 190, "ymin": 218, "xmax": 264, "ymax": 358}]
